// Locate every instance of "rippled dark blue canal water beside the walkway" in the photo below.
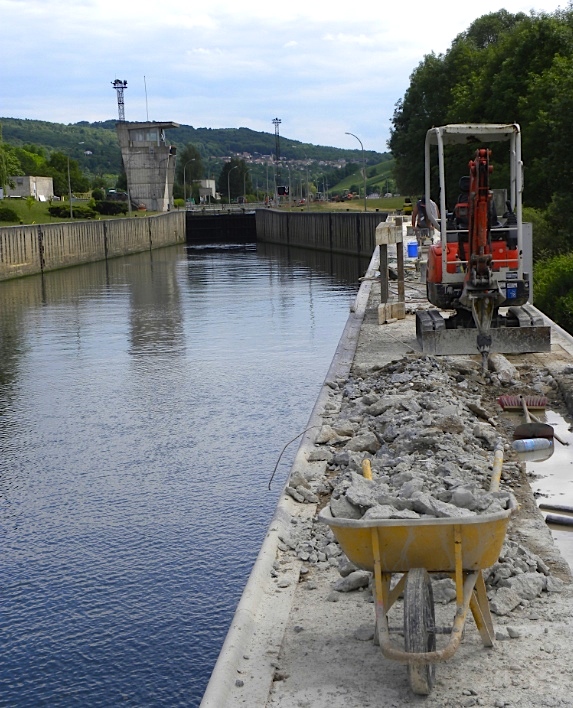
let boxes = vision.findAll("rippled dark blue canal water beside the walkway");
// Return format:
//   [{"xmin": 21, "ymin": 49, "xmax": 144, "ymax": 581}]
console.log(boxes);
[{"xmin": 0, "ymin": 241, "xmax": 367, "ymax": 708}]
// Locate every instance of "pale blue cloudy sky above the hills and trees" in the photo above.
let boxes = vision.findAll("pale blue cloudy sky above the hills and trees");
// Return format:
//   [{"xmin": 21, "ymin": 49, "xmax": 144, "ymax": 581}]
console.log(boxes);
[{"xmin": 0, "ymin": 0, "xmax": 566, "ymax": 152}]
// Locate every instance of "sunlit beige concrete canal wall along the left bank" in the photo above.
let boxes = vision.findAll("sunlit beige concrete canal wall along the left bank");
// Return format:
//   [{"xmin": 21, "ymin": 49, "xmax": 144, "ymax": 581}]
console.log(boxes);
[{"xmin": 0, "ymin": 212, "xmax": 185, "ymax": 280}]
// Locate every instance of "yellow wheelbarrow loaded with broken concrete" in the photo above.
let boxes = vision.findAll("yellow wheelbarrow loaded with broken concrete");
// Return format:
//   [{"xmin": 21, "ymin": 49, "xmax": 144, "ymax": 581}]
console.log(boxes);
[{"xmin": 319, "ymin": 453, "xmax": 517, "ymax": 695}]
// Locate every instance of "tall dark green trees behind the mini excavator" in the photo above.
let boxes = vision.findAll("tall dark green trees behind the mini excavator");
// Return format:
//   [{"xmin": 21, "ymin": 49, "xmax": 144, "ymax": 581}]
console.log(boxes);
[{"xmin": 388, "ymin": 6, "xmax": 573, "ymax": 331}]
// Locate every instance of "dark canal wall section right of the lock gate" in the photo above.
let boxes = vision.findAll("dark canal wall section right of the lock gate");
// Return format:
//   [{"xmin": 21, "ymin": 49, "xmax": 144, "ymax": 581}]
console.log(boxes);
[{"xmin": 256, "ymin": 209, "xmax": 388, "ymax": 258}]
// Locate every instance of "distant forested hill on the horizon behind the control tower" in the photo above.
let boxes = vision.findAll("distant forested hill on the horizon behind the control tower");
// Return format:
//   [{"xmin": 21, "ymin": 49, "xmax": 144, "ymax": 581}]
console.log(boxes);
[{"xmin": 0, "ymin": 118, "xmax": 384, "ymax": 174}]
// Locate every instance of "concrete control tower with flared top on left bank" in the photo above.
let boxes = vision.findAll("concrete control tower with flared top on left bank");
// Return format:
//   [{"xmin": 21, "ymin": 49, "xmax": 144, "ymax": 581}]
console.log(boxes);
[{"xmin": 116, "ymin": 121, "xmax": 179, "ymax": 211}]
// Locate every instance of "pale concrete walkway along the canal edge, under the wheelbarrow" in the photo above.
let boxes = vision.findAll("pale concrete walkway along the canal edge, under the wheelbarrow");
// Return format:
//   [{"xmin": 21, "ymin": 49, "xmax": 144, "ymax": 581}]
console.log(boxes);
[{"xmin": 201, "ymin": 252, "xmax": 573, "ymax": 708}]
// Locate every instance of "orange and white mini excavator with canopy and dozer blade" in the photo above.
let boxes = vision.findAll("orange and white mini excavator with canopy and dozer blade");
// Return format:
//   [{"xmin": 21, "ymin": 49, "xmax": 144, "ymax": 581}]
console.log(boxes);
[{"xmin": 416, "ymin": 123, "xmax": 551, "ymax": 369}]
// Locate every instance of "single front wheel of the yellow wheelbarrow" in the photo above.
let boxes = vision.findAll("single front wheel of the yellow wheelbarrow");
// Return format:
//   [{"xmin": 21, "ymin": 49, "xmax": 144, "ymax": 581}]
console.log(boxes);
[{"xmin": 404, "ymin": 568, "xmax": 436, "ymax": 696}]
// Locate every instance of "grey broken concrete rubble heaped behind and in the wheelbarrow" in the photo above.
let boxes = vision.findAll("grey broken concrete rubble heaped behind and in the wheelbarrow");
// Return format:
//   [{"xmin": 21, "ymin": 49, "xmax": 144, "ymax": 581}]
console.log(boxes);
[{"xmin": 282, "ymin": 356, "xmax": 561, "ymax": 614}]
